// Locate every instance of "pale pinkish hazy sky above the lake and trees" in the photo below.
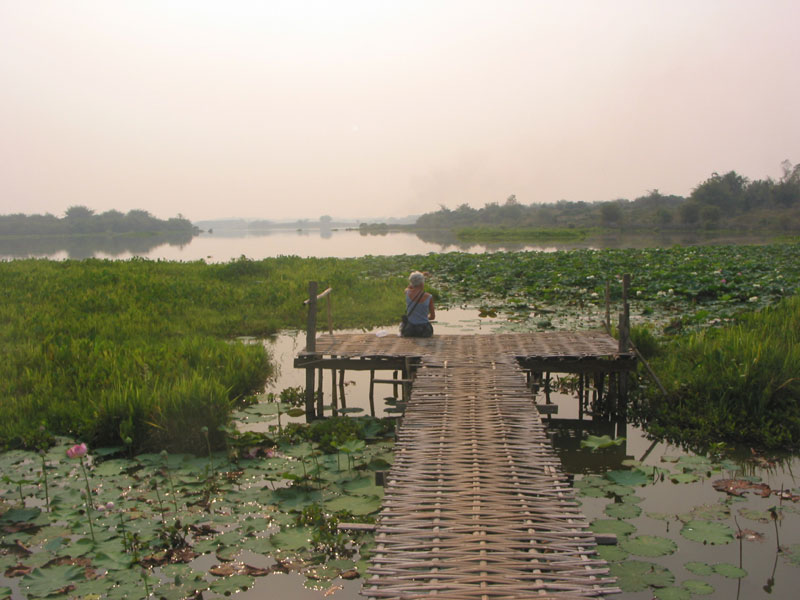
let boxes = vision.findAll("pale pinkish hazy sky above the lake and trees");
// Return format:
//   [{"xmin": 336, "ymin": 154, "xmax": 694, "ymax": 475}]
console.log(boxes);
[{"xmin": 0, "ymin": 0, "xmax": 800, "ymax": 220}]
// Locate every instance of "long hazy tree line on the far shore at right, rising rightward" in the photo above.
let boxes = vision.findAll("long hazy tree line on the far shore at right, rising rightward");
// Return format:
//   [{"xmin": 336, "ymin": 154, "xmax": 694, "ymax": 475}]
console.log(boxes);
[{"xmin": 416, "ymin": 161, "xmax": 800, "ymax": 229}]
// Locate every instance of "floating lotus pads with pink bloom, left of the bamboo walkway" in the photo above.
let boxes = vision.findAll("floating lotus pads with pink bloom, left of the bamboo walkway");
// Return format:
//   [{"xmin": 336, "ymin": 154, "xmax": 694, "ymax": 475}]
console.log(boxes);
[{"xmin": 0, "ymin": 412, "xmax": 394, "ymax": 598}]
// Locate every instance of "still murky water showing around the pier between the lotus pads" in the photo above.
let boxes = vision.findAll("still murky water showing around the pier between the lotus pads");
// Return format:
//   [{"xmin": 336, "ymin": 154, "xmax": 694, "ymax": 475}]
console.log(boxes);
[{"xmin": 258, "ymin": 309, "xmax": 800, "ymax": 600}]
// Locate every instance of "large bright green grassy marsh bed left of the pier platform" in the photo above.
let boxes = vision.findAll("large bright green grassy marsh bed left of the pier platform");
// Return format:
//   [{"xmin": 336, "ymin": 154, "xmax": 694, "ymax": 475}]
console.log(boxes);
[{"xmin": 0, "ymin": 257, "xmax": 403, "ymax": 451}]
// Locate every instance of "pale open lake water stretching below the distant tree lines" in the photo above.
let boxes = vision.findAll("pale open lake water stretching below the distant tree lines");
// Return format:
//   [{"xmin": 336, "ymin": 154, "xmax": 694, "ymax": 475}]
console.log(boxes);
[{"xmin": 0, "ymin": 229, "xmax": 776, "ymax": 263}]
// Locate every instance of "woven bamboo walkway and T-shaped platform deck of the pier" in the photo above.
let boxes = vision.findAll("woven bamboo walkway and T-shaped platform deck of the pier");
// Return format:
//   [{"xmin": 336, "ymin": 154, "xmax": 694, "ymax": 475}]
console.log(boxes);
[{"xmin": 295, "ymin": 332, "xmax": 634, "ymax": 600}]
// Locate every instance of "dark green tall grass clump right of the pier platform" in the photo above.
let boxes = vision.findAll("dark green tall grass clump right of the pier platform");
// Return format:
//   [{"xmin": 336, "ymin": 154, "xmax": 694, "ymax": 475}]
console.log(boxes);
[{"xmin": 646, "ymin": 296, "xmax": 800, "ymax": 448}]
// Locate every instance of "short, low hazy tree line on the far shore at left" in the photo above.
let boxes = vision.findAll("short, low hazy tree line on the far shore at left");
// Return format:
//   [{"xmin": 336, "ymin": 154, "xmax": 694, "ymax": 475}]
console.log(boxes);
[{"xmin": 0, "ymin": 206, "xmax": 199, "ymax": 235}]
